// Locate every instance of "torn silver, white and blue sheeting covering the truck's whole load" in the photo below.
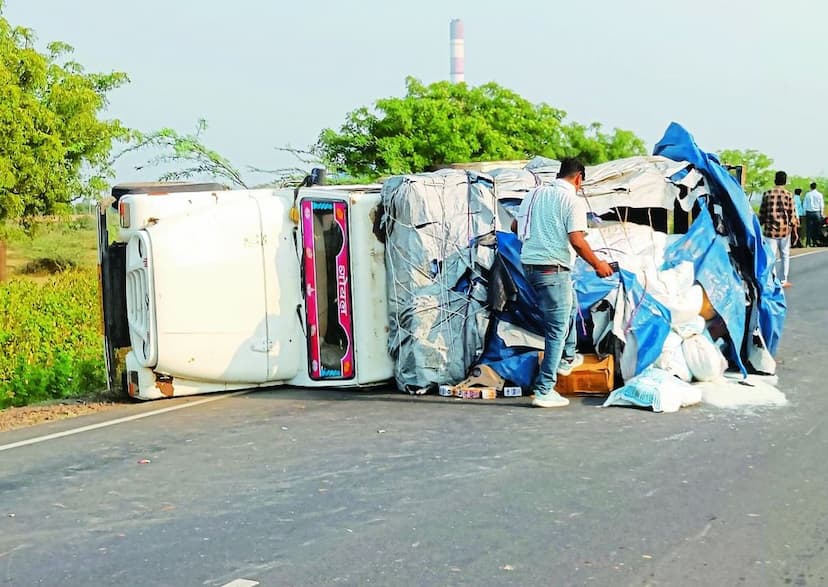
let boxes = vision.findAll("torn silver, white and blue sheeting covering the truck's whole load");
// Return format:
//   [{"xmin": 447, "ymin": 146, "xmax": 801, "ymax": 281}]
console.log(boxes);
[{"xmin": 380, "ymin": 125, "xmax": 785, "ymax": 391}]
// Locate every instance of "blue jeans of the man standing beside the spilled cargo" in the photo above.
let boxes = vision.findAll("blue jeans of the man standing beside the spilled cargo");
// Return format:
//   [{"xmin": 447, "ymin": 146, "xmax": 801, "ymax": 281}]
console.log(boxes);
[{"xmin": 523, "ymin": 265, "xmax": 578, "ymax": 395}]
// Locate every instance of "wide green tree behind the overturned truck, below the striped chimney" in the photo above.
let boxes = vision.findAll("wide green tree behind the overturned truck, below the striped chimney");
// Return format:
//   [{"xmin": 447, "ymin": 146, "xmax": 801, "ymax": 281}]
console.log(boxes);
[{"xmin": 314, "ymin": 77, "xmax": 646, "ymax": 177}]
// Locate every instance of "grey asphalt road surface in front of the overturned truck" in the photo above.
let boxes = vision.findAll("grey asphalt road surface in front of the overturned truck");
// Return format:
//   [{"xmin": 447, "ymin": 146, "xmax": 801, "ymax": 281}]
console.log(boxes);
[{"xmin": 0, "ymin": 254, "xmax": 828, "ymax": 587}]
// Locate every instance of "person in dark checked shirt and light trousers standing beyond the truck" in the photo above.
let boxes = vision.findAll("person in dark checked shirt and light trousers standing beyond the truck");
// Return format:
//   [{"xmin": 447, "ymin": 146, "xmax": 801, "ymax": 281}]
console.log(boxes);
[{"xmin": 759, "ymin": 171, "xmax": 799, "ymax": 287}]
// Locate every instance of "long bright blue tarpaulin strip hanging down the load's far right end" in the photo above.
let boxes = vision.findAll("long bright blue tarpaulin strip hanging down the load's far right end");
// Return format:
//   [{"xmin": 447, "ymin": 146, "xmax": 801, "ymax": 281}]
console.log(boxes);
[{"xmin": 653, "ymin": 122, "xmax": 786, "ymax": 354}]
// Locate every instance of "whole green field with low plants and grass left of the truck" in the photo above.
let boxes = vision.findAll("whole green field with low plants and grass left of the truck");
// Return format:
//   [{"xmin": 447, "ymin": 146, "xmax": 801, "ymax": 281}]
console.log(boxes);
[{"xmin": 0, "ymin": 216, "xmax": 105, "ymax": 408}]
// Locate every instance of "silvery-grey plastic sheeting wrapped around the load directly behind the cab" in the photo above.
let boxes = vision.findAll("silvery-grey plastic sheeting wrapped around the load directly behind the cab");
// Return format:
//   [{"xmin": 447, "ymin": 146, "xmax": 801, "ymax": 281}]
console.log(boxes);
[{"xmin": 378, "ymin": 170, "xmax": 502, "ymax": 390}]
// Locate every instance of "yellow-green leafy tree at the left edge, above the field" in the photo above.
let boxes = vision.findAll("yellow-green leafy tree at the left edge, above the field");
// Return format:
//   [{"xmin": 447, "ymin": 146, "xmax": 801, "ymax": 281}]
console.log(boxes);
[{"xmin": 0, "ymin": 0, "xmax": 128, "ymax": 219}]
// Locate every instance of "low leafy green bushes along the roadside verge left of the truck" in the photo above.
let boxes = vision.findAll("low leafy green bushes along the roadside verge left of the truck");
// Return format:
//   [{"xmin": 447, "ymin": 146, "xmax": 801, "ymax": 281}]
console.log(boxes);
[{"xmin": 0, "ymin": 269, "xmax": 106, "ymax": 408}]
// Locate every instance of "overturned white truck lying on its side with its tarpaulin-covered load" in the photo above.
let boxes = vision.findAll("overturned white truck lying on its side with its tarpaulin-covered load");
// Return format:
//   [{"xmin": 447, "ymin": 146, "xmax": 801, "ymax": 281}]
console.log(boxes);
[{"xmin": 99, "ymin": 125, "xmax": 785, "ymax": 399}]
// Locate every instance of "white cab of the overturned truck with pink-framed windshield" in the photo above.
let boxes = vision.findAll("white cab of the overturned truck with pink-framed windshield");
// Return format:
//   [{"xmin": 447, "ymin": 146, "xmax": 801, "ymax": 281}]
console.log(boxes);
[{"xmin": 99, "ymin": 184, "xmax": 393, "ymax": 399}]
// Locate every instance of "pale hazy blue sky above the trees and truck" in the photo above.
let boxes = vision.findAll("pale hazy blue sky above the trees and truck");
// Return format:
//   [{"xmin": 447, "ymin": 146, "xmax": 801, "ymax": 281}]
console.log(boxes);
[{"xmin": 5, "ymin": 0, "xmax": 828, "ymax": 181}]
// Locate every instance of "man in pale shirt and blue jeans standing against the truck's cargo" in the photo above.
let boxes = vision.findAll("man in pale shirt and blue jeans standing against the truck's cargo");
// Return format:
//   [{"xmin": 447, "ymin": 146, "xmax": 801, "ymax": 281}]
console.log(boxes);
[{"xmin": 512, "ymin": 159, "xmax": 612, "ymax": 408}]
